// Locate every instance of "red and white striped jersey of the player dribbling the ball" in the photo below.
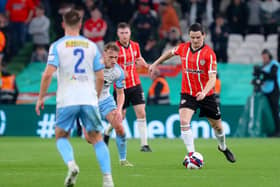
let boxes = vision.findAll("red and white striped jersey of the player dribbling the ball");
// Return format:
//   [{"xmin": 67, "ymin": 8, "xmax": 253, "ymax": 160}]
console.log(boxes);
[{"xmin": 172, "ymin": 42, "xmax": 217, "ymax": 96}]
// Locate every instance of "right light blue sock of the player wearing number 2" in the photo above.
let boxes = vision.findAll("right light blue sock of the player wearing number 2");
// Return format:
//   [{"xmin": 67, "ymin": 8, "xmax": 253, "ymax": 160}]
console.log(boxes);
[{"xmin": 93, "ymin": 141, "xmax": 111, "ymax": 174}]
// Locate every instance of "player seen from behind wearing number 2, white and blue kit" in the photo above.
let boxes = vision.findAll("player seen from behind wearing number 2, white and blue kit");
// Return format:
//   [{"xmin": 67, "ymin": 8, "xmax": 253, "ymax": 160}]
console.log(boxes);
[{"xmin": 36, "ymin": 10, "xmax": 114, "ymax": 187}]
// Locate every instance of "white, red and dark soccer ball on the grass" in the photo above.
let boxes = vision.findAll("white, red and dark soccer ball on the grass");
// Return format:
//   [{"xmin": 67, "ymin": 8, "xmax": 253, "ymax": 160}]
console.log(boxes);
[{"xmin": 183, "ymin": 152, "xmax": 204, "ymax": 169}]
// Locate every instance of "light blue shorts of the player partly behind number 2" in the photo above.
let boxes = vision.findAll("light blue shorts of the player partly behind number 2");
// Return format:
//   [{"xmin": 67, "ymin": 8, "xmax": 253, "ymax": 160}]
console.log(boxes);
[{"xmin": 98, "ymin": 96, "xmax": 117, "ymax": 119}]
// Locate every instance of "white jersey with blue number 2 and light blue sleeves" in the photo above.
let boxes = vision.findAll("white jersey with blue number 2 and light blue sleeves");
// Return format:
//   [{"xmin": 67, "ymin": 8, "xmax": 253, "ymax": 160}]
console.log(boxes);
[{"xmin": 48, "ymin": 36, "xmax": 104, "ymax": 108}]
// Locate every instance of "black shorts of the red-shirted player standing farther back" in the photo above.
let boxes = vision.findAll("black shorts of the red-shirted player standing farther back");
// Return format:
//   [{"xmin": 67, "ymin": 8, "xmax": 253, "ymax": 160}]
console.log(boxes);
[{"xmin": 113, "ymin": 84, "xmax": 145, "ymax": 109}]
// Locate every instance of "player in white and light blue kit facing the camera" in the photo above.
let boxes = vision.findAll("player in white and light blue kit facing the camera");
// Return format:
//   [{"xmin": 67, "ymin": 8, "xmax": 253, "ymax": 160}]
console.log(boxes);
[{"xmin": 85, "ymin": 42, "xmax": 133, "ymax": 167}]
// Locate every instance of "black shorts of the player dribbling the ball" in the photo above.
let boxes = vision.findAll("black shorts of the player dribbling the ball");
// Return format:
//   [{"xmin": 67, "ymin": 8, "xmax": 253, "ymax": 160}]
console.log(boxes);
[{"xmin": 179, "ymin": 93, "xmax": 221, "ymax": 120}]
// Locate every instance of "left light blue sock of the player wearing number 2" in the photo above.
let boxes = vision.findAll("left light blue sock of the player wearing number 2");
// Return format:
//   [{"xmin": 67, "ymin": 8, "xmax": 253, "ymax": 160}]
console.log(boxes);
[{"xmin": 56, "ymin": 138, "xmax": 74, "ymax": 165}]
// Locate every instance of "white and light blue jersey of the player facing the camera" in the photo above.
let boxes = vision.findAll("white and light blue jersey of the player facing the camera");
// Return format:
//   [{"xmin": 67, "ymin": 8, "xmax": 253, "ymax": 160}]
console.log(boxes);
[{"xmin": 99, "ymin": 64, "xmax": 124, "ymax": 102}]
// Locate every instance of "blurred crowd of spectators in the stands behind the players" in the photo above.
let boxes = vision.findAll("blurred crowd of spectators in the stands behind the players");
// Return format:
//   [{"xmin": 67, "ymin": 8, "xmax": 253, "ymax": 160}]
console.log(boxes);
[{"xmin": 0, "ymin": 0, "xmax": 280, "ymax": 64}]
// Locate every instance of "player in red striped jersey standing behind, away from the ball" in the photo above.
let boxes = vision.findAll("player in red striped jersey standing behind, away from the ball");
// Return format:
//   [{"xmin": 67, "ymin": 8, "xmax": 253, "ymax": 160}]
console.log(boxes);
[{"xmin": 104, "ymin": 23, "xmax": 152, "ymax": 152}]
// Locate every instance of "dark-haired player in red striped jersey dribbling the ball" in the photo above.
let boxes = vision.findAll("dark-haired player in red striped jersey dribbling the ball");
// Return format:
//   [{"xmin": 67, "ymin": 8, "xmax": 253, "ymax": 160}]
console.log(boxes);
[{"xmin": 149, "ymin": 23, "xmax": 235, "ymax": 162}]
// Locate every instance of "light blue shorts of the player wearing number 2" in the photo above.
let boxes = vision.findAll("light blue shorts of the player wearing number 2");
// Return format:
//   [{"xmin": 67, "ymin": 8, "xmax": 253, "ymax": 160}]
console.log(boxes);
[{"xmin": 56, "ymin": 105, "xmax": 103, "ymax": 132}]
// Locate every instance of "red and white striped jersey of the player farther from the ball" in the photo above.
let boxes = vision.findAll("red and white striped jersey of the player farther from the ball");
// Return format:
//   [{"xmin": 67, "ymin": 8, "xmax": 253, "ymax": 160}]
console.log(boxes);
[{"xmin": 116, "ymin": 40, "xmax": 141, "ymax": 88}]
